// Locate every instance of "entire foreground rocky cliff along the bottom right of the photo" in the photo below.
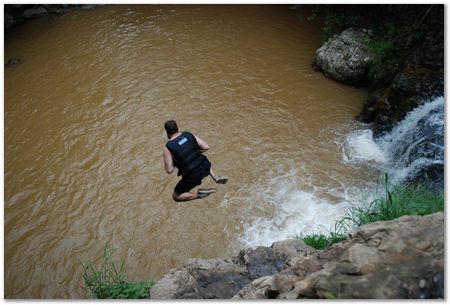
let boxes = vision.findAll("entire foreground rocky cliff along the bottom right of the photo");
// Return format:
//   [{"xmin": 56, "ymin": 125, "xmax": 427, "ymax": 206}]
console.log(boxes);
[{"xmin": 151, "ymin": 212, "xmax": 445, "ymax": 299}]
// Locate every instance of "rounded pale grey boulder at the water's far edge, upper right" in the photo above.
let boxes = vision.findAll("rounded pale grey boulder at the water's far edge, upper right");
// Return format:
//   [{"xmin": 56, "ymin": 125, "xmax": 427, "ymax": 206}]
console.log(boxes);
[{"xmin": 313, "ymin": 28, "xmax": 373, "ymax": 86}]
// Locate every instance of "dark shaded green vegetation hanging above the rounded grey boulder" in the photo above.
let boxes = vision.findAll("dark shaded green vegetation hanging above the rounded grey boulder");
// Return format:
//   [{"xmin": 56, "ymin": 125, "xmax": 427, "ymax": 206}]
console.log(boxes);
[{"xmin": 290, "ymin": 4, "xmax": 444, "ymax": 88}]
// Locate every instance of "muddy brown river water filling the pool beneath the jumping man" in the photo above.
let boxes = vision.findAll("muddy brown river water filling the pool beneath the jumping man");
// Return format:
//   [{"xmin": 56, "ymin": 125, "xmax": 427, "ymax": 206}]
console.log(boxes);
[{"xmin": 4, "ymin": 5, "xmax": 379, "ymax": 298}]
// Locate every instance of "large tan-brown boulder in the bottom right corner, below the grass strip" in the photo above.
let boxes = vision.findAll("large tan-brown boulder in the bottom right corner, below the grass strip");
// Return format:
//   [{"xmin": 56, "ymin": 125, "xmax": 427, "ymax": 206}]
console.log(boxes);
[{"xmin": 234, "ymin": 212, "xmax": 445, "ymax": 299}]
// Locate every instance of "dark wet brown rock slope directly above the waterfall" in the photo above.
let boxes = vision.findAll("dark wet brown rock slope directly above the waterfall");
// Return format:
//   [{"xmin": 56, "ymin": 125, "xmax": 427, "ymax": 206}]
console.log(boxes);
[{"xmin": 357, "ymin": 17, "xmax": 444, "ymax": 136}]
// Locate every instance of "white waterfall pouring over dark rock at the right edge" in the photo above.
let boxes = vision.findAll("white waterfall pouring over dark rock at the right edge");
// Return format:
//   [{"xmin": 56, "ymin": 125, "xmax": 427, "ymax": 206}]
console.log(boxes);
[{"xmin": 343, "ymin": 97, "xmax": 444, "ymax": 185}]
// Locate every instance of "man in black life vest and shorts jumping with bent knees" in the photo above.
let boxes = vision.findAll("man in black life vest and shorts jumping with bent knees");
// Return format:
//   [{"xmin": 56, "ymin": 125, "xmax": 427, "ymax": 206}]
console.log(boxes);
[{"xmin": 163, "ymin": 120, "xmax": 228, "ymax": 201}]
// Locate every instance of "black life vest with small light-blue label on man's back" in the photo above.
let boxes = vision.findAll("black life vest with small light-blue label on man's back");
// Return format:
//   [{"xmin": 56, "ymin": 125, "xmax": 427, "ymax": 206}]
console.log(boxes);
[{"xmin": 166, "ymin": 131, "xmax": 205, "ymax": 175}]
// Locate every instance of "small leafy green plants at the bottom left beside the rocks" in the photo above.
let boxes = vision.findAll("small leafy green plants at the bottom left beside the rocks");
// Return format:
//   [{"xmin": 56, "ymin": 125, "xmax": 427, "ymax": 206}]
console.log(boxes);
[{"xmin": 81, "ymin": 244, "xmax": 156, "ymax": 299}]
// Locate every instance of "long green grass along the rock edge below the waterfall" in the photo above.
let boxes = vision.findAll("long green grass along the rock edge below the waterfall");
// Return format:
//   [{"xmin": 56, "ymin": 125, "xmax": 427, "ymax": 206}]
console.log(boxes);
[{"xmin": 296, "ymin": 175, "xmax": 444, "ymax": 249}]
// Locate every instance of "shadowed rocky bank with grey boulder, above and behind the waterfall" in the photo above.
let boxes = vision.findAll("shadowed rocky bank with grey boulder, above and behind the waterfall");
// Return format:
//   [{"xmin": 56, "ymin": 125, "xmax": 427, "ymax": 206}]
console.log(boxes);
[{"xmin": 313, "ymin": 5, "xmax": 444, "ymax": 191}]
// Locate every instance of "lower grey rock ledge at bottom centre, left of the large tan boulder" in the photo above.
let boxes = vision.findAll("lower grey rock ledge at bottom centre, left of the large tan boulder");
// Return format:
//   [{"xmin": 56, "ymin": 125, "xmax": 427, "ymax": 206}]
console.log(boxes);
[{"xmin": 150, "ymin": 240, "xmax": 315, "ymax": 299}]
